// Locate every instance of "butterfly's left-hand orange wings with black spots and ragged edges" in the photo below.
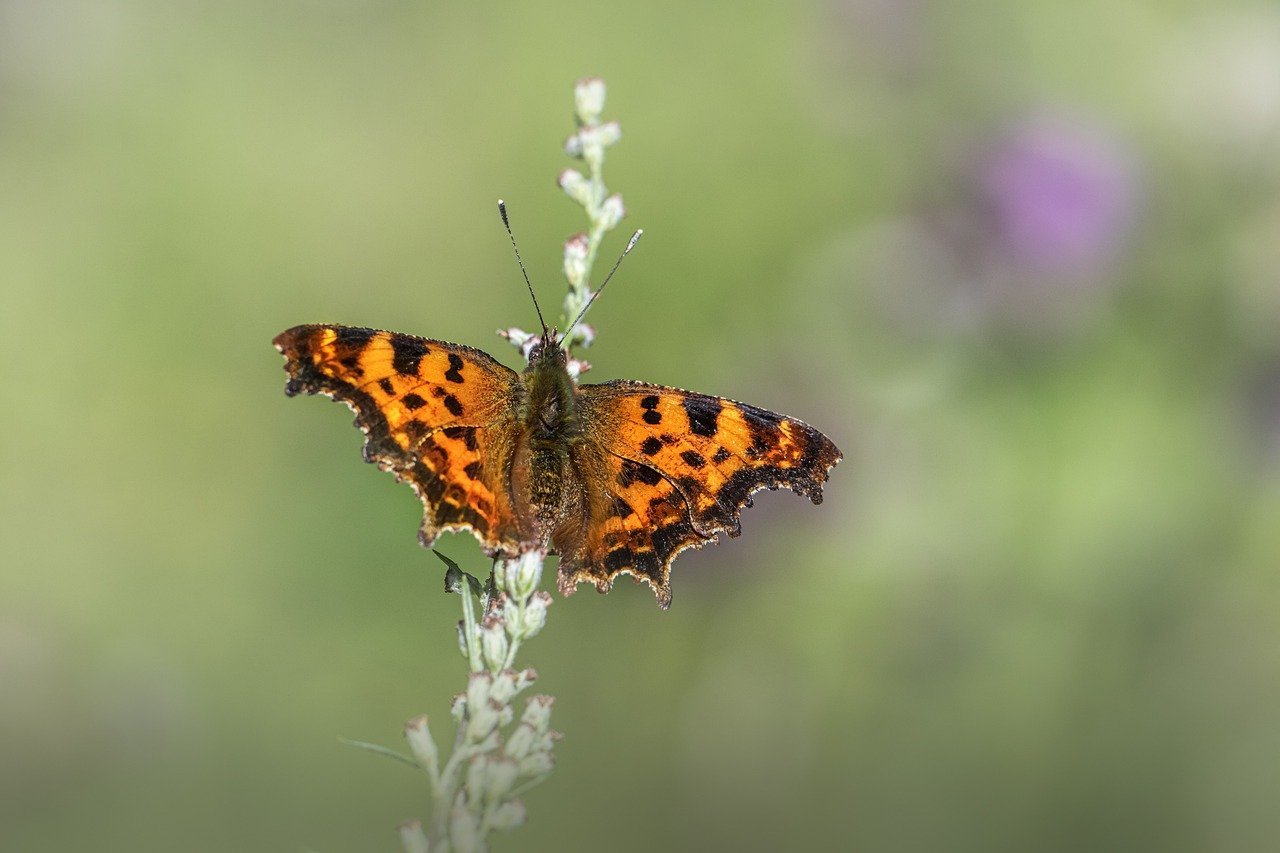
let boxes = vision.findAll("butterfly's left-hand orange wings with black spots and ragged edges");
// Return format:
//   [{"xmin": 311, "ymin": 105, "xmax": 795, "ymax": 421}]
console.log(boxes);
[{"xmin": 273, "ymin": 325, "xmax": 524, "ymax": 553}]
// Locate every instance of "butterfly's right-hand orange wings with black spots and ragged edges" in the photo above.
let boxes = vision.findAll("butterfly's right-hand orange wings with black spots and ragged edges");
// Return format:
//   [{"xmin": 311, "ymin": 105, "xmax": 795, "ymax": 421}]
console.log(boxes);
[{"xmin": 559, "ymin": 382, "xmax": 842, "ymax": 607}]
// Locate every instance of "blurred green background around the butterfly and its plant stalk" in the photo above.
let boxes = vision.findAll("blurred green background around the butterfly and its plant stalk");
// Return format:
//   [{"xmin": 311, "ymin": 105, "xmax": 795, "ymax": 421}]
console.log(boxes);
[{"xmin": 0, "ymin": 0, "xmax": 1280, "ymax": 852}]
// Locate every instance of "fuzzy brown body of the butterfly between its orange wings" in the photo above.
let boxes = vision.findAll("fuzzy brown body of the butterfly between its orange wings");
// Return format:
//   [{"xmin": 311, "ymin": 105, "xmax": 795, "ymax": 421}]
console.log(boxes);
[{"xmin": 512, "ymin": 336, "xmax": 582, "ymax": 542}]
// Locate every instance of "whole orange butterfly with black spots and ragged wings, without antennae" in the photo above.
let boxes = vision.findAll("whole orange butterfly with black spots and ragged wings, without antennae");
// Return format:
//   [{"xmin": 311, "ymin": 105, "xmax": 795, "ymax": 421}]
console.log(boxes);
[{"xmin": 275, "ymin": 325, "xmax": 841, "ymax": 607}]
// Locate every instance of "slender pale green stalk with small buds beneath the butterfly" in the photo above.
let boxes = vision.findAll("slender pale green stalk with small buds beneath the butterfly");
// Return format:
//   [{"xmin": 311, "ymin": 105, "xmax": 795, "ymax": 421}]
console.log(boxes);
[{"xmin": 348, "ymin": 78, "xmax": 635, "ymax": 853}]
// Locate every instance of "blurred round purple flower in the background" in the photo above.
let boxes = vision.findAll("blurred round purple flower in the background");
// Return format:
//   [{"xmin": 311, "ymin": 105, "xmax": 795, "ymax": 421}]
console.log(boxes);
[{"xmin": 975, "ymin": 118, "xmax": 1135, "ymax": 274}]
